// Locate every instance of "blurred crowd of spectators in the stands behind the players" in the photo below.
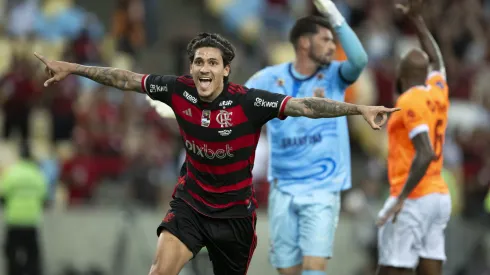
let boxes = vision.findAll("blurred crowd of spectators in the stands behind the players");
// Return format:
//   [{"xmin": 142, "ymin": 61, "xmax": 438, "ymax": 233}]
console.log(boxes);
[{"xmin": 0, "ymin": 0, "xmax": 490, "ymax": 274}]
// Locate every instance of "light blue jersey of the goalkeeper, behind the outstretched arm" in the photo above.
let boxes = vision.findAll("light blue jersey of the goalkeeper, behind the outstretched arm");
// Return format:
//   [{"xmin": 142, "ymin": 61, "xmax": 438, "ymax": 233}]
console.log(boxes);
[{"xmin": 245, "ymin": 62, "xmax": 351, "ymax": 195}]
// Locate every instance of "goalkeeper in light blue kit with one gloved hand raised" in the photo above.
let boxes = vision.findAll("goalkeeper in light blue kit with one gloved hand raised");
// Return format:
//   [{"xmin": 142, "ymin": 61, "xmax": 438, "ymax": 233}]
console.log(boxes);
[{"xmin": 245, "ymin": 0, "xmax": 367, "ymax": 275}]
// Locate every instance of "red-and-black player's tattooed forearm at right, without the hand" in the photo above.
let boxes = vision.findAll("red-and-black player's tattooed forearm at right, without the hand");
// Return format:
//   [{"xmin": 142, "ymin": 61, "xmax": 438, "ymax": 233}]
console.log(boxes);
[{"xmin": 284, "ymin": 97, "xmax": 361, "ymax": 118}]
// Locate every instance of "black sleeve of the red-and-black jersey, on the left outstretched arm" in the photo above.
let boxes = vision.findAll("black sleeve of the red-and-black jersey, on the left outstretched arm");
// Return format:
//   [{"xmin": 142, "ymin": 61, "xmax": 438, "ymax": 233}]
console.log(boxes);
[{"xmin": 141, "ymin": 74, "xmax": 177, "ymax": 106}]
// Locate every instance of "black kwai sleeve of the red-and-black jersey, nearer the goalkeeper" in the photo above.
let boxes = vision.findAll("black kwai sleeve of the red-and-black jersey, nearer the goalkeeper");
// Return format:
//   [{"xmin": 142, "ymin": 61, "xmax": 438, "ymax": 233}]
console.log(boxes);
[{"xmin": 244, "ymin": 89, "xmax": 291, "ymax": 127}]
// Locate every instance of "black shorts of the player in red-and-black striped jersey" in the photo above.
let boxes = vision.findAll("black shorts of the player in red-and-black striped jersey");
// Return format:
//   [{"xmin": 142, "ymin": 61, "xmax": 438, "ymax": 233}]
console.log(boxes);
[{"xmin": 157, "ymin": 198, "xmax": 257, "ymax": 275}]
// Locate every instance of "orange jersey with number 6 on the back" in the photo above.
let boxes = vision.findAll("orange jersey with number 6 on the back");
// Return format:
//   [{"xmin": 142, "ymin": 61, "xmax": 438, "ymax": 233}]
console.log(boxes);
[{"xmin": 388, "ymin": 72, "xmax": 449, "ymax": 198}]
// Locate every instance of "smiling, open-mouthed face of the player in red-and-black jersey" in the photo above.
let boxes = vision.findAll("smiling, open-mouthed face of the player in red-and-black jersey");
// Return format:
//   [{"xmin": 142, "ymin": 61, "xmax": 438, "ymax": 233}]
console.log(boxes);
[{"xmin": 191, "ymin": 47, "xmax": 230, "ymax": 101}]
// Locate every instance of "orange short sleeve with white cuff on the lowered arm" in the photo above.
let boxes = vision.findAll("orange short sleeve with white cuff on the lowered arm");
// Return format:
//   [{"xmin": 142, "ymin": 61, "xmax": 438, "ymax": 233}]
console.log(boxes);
[{"xmin": 397, "ymin": 91, "xmax": 431, "ymax": 139}]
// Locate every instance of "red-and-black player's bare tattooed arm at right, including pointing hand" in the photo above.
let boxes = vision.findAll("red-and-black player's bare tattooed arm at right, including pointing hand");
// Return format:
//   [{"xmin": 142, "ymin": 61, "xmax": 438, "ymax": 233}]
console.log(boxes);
[{"xmin": 284, "ymin": 97, "xmax": 400, "ymax": 129}]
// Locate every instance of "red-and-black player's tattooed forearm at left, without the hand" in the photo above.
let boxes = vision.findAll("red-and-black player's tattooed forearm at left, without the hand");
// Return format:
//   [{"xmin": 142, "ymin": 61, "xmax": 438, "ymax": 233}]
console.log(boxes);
[{"xmin": 73, "ymin": 65, "xmax": 143, "ymax": 92}]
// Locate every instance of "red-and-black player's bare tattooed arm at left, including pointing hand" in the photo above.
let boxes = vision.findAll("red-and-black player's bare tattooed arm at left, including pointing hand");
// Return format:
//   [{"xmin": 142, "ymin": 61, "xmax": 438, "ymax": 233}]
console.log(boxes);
[{"xmin": 34, "ymin": 53, "xmax": 144, "ymax": 92}]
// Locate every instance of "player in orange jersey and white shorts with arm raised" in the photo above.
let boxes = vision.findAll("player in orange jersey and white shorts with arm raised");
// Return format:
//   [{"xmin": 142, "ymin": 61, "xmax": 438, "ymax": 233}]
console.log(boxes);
[{"xmin": 377, "ymin": 0, "xmax": 451, "ymax": 275}]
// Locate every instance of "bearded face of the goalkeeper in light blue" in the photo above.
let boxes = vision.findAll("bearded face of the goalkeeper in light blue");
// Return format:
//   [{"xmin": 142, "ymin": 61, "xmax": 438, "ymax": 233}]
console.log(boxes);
[{"xmin": 309, "ymin": 26, "xmax": 336, "ymax": 65}]
